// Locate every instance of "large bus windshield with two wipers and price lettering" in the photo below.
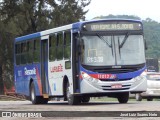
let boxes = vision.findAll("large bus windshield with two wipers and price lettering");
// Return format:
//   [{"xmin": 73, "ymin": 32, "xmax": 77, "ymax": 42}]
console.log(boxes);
[{"xmin": 81, "ymin": 34, "xmax": 145, "ymax": 66}]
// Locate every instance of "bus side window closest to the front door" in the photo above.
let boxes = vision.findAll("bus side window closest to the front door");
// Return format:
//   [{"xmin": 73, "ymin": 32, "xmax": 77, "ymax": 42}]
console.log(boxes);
[{"xmin": 64, "ymin": 31, "xmax": 71, "ymax": 59}]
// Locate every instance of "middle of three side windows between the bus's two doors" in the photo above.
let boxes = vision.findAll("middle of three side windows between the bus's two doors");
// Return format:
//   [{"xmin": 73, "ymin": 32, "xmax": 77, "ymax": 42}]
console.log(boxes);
[{"xmin": 57, "ymin": 33, "xmax": 63, "ymax": 60}]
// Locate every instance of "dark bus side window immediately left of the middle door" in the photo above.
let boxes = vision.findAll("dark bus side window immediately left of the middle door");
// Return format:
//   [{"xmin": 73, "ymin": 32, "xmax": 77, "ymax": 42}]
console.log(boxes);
[{"xmin": 33, "ymin": 39, "xmax": 40, "ymax": 62}]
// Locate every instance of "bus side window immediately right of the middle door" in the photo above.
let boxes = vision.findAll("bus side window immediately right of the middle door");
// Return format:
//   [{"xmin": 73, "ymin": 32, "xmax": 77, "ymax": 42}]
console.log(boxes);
[{"xmin": 49, "ymin": 34, "xmax": 57, "ymax": 61}]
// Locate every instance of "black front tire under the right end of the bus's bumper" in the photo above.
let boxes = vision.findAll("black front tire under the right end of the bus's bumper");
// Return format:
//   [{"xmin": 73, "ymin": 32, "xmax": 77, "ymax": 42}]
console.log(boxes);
[{"xmin": 118, "ymin": 92, "xmax": 129, "ymax": 103}]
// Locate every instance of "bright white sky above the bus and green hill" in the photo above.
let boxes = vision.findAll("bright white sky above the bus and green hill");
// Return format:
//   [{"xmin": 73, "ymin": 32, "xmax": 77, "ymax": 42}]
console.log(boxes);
[{"xmin": 85, "ymin": 0, "xmax": 160, "ymax": 22}]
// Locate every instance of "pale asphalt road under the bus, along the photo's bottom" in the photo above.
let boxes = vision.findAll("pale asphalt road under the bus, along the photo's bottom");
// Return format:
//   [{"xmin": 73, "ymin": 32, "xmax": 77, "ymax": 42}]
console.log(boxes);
[{"xmin": 0, "ymin": 101, "xmax": 160, "ymax": 120}]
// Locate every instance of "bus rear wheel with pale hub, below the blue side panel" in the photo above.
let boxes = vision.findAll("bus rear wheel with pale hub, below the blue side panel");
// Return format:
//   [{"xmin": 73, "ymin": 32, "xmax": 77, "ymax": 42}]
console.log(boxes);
[{"xmin": 30, "ymin": 82, "xmax": 41, "ymax": 104}]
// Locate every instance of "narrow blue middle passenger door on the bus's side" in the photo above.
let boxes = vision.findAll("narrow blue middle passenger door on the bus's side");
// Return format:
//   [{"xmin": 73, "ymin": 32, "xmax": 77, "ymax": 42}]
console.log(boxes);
[{"xmin": 41, "ymin": 36, "xmax": 49, "ymax": 98}]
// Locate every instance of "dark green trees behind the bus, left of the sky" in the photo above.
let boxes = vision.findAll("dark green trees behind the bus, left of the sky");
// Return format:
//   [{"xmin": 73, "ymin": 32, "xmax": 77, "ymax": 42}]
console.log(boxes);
[{"xmin": 0, "ymin": 0, "xmax": 91, "ymax": 93}]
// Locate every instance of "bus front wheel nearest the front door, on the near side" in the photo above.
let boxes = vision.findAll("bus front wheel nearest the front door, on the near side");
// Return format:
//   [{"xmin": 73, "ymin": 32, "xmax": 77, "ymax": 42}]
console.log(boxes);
[{"xmin": 66, "ymin": 82, "xmax": 81, "ymax": 105}]
